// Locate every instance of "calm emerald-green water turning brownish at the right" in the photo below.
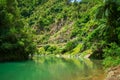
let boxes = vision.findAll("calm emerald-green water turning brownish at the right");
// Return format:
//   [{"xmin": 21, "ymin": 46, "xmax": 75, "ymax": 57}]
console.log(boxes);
[{"xmin": 0, "ymin": 57, "xmax": 104, "ymax": 80}]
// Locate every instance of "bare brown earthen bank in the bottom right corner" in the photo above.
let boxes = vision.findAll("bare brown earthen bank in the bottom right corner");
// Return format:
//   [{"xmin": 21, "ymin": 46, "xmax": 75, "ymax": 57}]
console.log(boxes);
[{"xmin": 105, "ymin": 65, "xmax": 120, "ymax": 80}]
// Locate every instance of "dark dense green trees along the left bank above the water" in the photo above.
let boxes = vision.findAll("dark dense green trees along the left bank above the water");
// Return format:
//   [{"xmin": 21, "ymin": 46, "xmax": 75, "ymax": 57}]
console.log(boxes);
[{"xmin": 0, "ymin": 0, "xmax": 36, "ymax": 61}]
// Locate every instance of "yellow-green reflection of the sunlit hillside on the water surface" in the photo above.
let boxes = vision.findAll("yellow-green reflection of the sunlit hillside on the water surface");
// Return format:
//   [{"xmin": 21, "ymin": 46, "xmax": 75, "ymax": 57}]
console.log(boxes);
[{"xmin": 33, "ymin": 57, "xmax": 104, "ymax": 80}]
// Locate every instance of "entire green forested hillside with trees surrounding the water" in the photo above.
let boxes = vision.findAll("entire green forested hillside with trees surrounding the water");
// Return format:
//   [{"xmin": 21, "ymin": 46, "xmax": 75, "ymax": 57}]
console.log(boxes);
[{"xmin": 0, "ymin": 0, "xmax": 120, "ymax": 67}]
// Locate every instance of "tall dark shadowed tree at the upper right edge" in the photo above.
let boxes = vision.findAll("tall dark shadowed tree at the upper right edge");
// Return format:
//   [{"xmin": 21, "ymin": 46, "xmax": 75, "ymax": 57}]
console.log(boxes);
[{"xmin": 96, "ymin": 0, "xmax": 120, "ymax": 42}]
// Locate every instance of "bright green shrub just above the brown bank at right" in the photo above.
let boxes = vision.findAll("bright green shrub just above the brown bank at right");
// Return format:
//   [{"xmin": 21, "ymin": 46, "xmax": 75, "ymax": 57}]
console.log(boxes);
[{"xmin": 103, "ymin": 43, "xmax": 120, "ymax": 67}]
